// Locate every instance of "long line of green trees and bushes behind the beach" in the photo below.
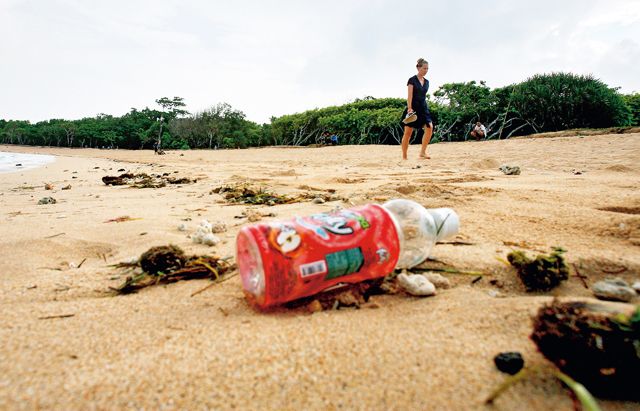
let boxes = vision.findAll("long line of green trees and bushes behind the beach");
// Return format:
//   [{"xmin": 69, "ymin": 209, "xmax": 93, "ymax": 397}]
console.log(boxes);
[{"xmin": 0, "ymin": 73, "xmax": 640, "ymax": 149}]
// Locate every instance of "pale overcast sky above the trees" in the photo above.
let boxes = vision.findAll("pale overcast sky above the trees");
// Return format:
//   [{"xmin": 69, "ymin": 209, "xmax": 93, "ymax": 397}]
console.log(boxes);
[{"xmin": 0, "ymin": 0, "xmax": 640, "ymax": 123}]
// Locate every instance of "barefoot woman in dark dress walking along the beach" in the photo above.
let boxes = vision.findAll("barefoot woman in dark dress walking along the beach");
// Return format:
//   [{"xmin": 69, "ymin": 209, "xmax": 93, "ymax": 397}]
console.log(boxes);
[{"xmin": 402, "ymin": 58, "xmax": 433, "ymax": 160}]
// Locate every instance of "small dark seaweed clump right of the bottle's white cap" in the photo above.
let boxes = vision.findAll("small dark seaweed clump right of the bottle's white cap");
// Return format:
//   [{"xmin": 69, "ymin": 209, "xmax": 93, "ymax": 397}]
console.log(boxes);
[{"xmin": 507, "ymin": 247, "xmax": 569, "ymax": 291}]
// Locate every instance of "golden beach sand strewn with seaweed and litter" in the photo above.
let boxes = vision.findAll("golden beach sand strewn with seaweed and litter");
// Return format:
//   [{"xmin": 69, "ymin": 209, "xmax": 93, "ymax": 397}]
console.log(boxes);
[{"xmin": 0, "ymin": 134, "xmax": 640, "ymax": 410}]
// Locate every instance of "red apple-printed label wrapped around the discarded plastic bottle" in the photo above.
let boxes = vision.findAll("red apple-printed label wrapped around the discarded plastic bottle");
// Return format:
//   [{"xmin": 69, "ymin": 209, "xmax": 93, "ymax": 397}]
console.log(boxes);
[{"xmin": 237, "ymin": 204, "xmax": 399, "ymax": 307}]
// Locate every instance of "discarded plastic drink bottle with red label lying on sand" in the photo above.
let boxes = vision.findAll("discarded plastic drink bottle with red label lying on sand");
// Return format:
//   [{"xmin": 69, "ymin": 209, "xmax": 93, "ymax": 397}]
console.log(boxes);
[{"xmin": 236, "ymin": 200, "xmax": 459, "ymax": 308}]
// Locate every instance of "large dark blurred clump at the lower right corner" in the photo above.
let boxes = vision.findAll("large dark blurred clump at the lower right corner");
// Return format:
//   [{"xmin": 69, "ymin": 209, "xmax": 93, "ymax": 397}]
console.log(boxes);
[{"xmin": 531, "ymin": 301, "xmax": 640, "ymax": 401}]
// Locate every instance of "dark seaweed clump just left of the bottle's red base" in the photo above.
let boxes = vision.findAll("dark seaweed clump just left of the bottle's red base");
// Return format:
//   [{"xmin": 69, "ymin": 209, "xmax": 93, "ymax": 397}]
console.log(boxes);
[{"xmin": 111, "ymin": 245, "xmax": 235, "ymax": 294}]
